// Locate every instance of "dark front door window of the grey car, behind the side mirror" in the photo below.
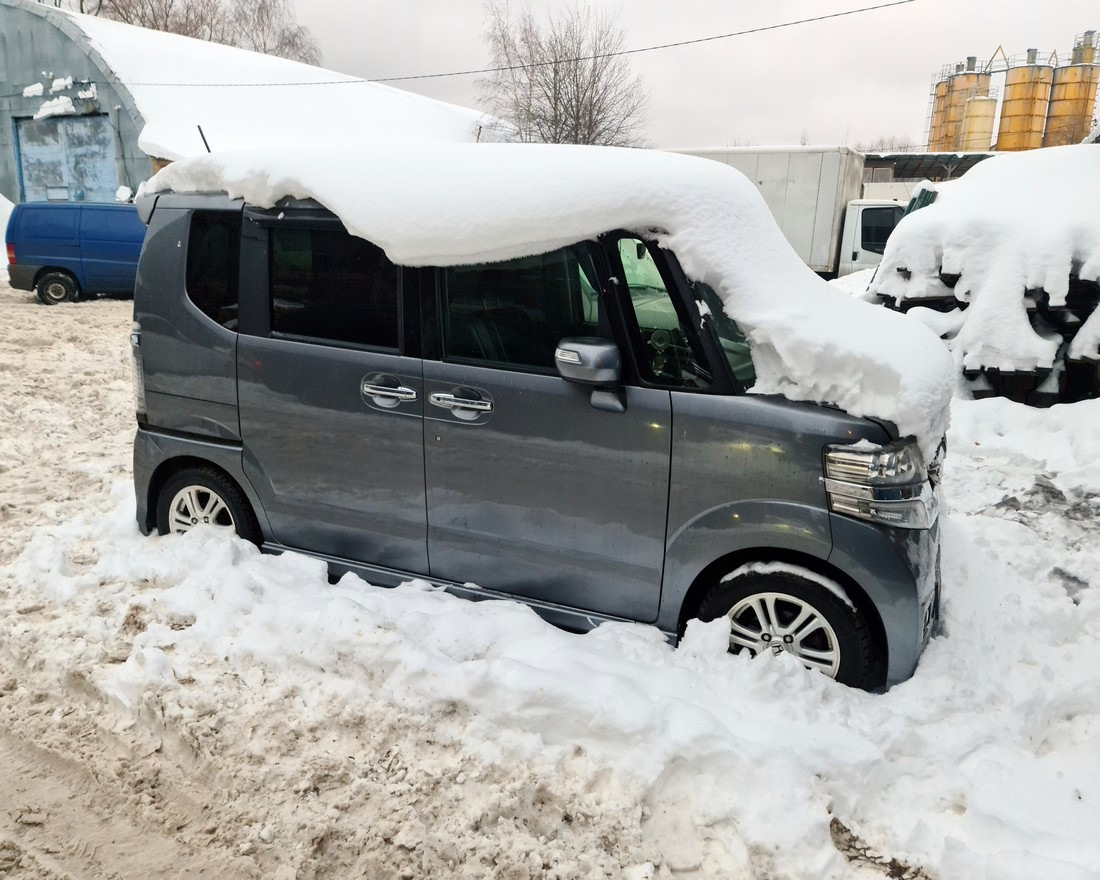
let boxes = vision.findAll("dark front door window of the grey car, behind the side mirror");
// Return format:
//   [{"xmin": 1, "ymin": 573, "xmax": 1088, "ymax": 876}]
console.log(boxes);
[{"xmin": 442, "ymin": 243, "xmax": 608, "ymax": 372}]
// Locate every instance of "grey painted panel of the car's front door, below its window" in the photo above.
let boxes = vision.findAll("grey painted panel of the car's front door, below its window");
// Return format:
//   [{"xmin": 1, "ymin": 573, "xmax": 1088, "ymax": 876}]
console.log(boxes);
[{"xmin": 425, "ymin": 361, "xmax": 671, "ymax": 622}]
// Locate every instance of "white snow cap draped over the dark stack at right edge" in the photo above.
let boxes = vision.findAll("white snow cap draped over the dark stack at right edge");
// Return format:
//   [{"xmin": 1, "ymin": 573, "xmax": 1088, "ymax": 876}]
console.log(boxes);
[{"xmin": 870, "ymin": 145, "xmax": 1100, "ymax": 372}]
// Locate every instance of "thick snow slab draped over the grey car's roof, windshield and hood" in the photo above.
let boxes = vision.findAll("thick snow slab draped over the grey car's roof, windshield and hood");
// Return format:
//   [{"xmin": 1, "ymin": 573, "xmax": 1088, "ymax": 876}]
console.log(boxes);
[{"xmin": 143, "ymin": 144, "xmax": 954, "ymax": 454}]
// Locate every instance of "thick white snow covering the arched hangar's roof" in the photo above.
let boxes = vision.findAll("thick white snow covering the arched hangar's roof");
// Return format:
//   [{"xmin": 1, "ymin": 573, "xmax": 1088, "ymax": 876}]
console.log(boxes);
[{"xmin": 45, "ymin": 3, "xmax": 484, "ymax": 160}]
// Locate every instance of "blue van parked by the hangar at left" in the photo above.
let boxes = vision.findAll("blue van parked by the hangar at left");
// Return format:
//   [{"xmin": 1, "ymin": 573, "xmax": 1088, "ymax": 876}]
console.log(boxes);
[{"xmin": 7, "ymin": 202, "xmax": 145, "ymax": 306}]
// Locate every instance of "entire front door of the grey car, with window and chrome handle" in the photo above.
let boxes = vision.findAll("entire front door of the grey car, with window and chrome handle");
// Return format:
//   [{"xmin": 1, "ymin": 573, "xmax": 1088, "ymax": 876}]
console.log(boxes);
[{"xmin": 424, "ymin": 244, "xmax": 671, "ymax": 620}]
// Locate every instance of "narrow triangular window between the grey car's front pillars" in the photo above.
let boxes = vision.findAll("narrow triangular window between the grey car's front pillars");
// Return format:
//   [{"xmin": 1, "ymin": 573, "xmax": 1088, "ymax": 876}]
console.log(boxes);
[{"xmin": 618, "ymin": 238, "xmax": 711, "ymax": 388}]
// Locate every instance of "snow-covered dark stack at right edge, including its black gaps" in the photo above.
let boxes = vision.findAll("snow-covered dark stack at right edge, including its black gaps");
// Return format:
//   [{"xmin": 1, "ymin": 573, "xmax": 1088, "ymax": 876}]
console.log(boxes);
[{"xmin": 868, "ymin": 144, "xmax": 1100, "ymax": 405}]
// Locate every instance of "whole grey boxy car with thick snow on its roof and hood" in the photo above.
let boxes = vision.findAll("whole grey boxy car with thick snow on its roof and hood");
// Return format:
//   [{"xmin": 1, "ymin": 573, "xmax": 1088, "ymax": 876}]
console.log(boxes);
[{"xmin": 132, "ymin": 144, "xmax": 952, "ymax": 689}]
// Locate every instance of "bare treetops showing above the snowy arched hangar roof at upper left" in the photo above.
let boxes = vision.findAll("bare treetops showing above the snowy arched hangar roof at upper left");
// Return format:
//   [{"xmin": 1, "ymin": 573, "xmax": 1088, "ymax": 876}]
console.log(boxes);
[{"xmin": 50, "ymin": 0, "xmax": 321, "ymax": 64}]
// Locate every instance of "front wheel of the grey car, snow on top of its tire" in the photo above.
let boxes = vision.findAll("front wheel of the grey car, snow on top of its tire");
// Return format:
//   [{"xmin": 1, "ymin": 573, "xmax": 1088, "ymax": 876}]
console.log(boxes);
[{"xmin": 697, "ymin": 565, "xmax": 880, "ymax": 689}]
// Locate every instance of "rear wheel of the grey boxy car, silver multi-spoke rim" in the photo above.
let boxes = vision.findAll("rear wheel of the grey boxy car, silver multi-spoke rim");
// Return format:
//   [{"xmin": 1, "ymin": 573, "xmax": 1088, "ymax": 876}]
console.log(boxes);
[{"xmin": 156, "ymin": 468, "xmax": 261, "ymax": 545}]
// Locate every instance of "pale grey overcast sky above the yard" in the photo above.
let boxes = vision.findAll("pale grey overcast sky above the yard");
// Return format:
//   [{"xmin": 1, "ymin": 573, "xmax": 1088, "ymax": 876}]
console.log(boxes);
[{"xmin": 294, "ymin": 0, "xmax": 1100, "ymax": 149}]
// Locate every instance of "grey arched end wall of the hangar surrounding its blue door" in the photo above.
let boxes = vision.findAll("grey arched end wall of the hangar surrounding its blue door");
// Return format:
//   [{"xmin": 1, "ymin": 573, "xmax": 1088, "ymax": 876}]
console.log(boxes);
[{"xmin": 0, "ymin": 0, "xmax": 153, "ymax": 201}]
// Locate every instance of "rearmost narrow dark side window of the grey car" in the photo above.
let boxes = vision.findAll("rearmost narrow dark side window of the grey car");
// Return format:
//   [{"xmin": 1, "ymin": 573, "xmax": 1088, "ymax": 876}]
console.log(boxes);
[{"xmin": 186, "ymin": 211, "xmax": 241, "ymax": 330}]
